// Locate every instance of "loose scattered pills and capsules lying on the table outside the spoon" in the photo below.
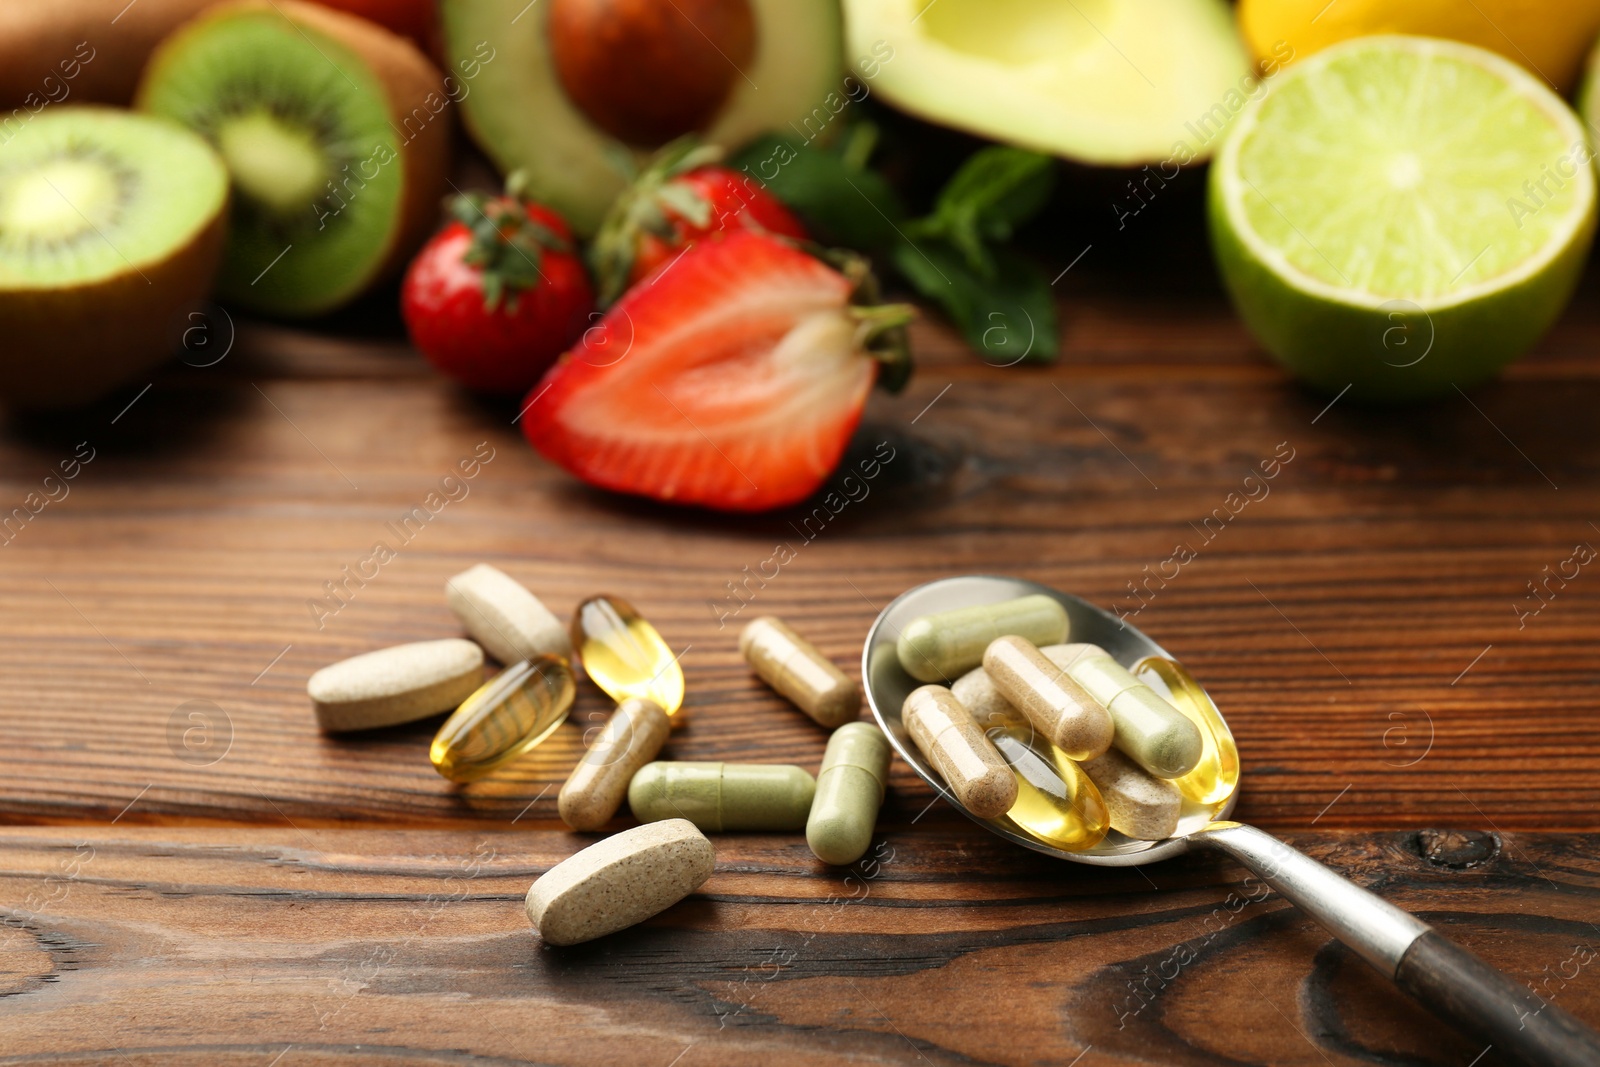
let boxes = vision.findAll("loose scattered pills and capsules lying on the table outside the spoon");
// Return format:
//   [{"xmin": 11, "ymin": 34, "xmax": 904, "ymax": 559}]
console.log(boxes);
[{"xmin": 307, "ymin": 563, "xmax": 896, "ymax": 944}]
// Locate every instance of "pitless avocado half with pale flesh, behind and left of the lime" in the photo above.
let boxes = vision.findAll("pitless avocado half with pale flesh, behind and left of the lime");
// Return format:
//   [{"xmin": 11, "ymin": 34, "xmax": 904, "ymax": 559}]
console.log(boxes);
[{"xmin": 845, "ymin": 0, "xmax": 1258, "ymax": 166}]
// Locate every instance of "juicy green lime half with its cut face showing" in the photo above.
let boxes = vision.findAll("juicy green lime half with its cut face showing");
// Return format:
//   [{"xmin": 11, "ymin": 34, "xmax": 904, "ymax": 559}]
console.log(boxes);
[{"xmin": 1210, "ymin": 37, "xmax": 1595, "ymax": 400}]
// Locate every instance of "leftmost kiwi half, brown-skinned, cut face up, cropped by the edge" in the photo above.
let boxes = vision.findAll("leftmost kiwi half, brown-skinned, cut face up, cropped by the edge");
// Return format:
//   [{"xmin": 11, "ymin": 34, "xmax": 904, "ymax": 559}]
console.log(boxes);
[{"xmin": 0, "ymin": 107, "xmax": 227, "ymax": 408}]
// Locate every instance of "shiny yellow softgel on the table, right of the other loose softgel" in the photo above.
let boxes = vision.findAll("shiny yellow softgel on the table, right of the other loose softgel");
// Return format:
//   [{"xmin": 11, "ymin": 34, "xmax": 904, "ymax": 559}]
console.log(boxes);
[{"xmin": 571, "ymin": 597, "xmax": 683, "ymax": 715}]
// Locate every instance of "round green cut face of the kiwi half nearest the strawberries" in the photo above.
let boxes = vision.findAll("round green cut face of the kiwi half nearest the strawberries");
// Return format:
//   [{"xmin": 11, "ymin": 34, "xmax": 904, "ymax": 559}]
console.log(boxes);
[{"xmin": 139, "ymin": 8, "xmax": 405, "ymax": 315}]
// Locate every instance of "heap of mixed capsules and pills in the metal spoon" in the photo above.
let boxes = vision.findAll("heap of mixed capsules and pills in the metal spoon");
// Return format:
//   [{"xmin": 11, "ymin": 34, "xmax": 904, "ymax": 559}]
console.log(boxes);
[{"xmin": 896, "ymin": 595, "xmax": 1238, "ymax": 851}]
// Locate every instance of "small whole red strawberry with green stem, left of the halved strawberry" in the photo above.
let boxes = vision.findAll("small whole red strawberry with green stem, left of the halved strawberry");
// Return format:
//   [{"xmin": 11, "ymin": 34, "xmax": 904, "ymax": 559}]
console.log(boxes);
[{"xmin": 400, "ymin": 176, "xmax": 594, "ymax": 394}]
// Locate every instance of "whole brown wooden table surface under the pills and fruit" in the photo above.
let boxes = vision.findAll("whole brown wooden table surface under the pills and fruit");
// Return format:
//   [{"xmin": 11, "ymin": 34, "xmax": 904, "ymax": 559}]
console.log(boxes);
[{"xmin": 0, "ymin": 230, "xmax": 1600, "ymax": 1067}]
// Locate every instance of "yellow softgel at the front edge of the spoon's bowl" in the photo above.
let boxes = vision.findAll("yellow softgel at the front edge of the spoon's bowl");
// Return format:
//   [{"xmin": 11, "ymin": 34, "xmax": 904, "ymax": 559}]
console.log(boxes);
[{"xmin": 989, "ymin": 723, "xmax": 1110, "ymax": 853}]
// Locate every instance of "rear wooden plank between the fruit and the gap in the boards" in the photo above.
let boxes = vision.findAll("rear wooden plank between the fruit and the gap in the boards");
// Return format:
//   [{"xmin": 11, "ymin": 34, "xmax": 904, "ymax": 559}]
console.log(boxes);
[{"xmin": 0, "ymin": 260, "xmax": 1600, "ymax": 830}]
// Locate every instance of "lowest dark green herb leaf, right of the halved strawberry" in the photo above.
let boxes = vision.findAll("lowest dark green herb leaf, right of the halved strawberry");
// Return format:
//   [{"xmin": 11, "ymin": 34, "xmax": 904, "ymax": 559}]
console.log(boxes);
[{"xmin": 891, "ymin": 238, "xmax": 1059, "ymax": 366}]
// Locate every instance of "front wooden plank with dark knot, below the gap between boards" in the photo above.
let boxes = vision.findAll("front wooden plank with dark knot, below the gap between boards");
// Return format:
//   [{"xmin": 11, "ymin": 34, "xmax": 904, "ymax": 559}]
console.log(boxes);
[{"xmin": 0, "ymin": 822, "xmax": 1600, "ymax": 1067}]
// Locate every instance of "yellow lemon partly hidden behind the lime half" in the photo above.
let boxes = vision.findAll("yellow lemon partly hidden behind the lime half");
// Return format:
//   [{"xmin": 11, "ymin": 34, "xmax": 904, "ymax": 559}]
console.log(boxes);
[{"xmin": 1238, "ymin": 0, "xmax": 1600, "ymax": 93}]
